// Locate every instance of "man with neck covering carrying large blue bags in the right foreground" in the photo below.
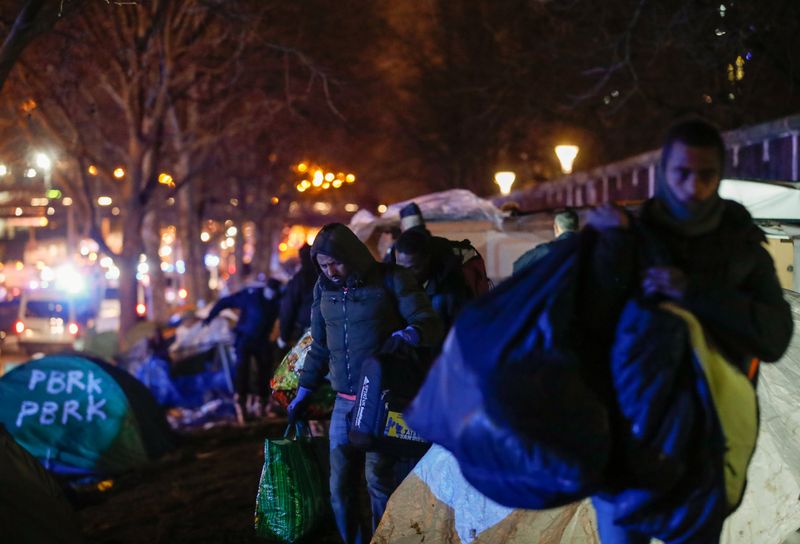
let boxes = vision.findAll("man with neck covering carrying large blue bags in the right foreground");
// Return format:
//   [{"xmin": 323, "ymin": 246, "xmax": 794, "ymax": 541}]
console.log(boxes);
[{"xmin": 406, "ymin": 120, "xmax": 793, "ymax": 544}]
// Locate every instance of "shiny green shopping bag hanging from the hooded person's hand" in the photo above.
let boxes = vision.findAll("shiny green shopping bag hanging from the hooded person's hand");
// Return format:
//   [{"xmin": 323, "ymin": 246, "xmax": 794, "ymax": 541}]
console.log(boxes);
[{"xmin": 255, "ymin": 423, "xmax": 328, "ymax": 543}]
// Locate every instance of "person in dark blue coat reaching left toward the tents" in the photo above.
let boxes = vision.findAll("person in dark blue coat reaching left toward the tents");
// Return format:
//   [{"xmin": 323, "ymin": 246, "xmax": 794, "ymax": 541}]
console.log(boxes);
[{"xmin": 203, "ymin": 268, "xmax": 280, "ymax": 420}]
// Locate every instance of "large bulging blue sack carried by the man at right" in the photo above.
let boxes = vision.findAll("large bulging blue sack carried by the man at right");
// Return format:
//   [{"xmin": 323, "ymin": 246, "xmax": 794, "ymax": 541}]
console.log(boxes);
[{"xmin": 406, "ymin": 233, "xmax": 610, "ymax": 509}]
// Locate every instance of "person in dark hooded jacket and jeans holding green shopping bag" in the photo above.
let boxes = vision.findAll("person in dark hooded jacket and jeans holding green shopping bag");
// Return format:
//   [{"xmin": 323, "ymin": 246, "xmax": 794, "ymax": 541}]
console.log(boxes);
[{"xmin": 288, "ymin": 223, "xmax": 441, "ymax": 543}]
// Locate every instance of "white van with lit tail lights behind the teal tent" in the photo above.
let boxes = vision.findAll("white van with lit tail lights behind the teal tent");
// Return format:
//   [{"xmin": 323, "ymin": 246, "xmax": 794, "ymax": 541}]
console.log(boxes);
[{"xmin": 14, "ymin": 289, "xmax": 81, "ymax": 354}]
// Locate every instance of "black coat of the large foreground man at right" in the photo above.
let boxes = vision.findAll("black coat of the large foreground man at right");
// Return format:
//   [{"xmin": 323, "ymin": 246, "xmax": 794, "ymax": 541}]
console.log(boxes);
[{"xmin": 640, "ymin": 200, "xmax": 794, "ymax": 372}]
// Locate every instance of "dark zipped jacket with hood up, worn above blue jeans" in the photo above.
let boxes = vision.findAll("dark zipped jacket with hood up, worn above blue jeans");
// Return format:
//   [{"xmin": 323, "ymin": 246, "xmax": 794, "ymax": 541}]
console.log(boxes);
[{"xmin": 300, "ymin": 223, "xmax": 442, "ymax": 395}]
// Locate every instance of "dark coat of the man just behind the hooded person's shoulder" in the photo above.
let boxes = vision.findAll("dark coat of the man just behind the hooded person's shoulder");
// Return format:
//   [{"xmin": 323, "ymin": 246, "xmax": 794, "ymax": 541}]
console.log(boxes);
[{"xmin": 425, "ymin": 237, "xmax": 473, "ymax": 332}]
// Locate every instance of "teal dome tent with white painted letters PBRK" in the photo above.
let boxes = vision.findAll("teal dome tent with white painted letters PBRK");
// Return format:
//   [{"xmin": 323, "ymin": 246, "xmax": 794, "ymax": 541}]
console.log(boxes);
[{"xmin": 0, "ymin": 355, "xmax": 172, "ymax": 474}]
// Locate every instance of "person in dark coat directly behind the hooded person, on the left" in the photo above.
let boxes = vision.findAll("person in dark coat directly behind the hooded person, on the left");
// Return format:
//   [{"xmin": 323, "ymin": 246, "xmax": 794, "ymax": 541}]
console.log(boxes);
[{"xmin": 278, "ymin": 244, "xmax": 319, "ymax": 349}]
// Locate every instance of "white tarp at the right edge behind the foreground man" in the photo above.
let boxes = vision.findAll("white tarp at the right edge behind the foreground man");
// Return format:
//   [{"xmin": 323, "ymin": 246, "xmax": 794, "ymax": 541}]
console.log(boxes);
[{"xmin": 719, "ymin": 179, "xmax": 800, "ymax": 220}]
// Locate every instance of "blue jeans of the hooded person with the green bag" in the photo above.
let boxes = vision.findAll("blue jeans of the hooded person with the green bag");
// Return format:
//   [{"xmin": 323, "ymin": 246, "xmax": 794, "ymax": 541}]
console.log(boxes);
[{"xmin": 329, "ymin": 397, "xmax": 418, "ymax": 544}]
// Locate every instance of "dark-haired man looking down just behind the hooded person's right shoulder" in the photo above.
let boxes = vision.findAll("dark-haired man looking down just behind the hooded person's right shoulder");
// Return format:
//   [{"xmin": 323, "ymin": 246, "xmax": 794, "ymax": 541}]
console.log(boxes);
[{"xmin": 395, "ymin": 229, "xmax": 473, "ymax": 332}]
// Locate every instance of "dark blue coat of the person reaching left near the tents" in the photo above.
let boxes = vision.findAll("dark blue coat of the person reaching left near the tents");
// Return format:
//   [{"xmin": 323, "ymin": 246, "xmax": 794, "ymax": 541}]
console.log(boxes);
[{"xmin": 206, "ymin": 283, "xmax": 279, "ymax": 341}]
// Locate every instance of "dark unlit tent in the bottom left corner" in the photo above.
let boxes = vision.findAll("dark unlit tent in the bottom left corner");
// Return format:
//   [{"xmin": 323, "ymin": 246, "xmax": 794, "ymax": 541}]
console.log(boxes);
[{"xmin": 0, "ymin": 425, "xmax": 83, "ymax": 544}]
